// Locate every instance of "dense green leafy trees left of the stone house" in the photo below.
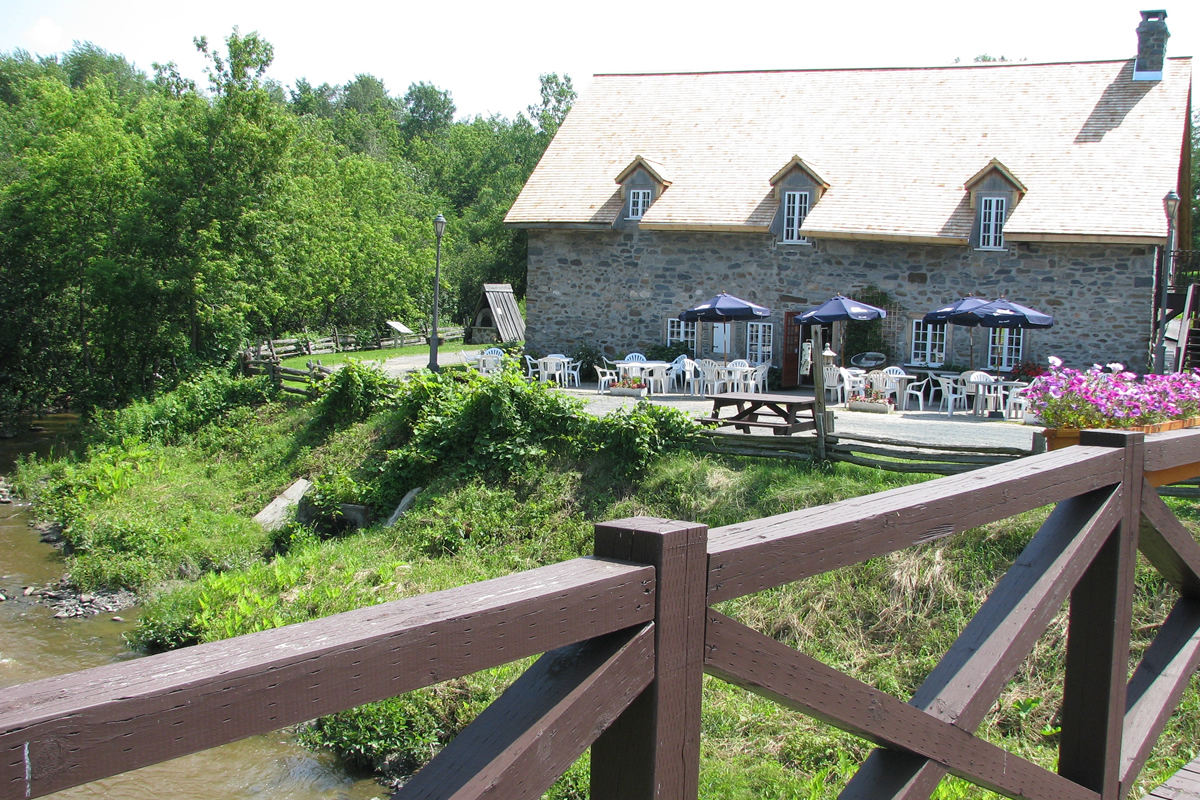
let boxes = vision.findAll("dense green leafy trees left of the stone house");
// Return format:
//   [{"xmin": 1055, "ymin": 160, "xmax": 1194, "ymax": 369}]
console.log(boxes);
[{"xmin": 0, "ymin": 29, "xmax": 575, "ymax": 413}]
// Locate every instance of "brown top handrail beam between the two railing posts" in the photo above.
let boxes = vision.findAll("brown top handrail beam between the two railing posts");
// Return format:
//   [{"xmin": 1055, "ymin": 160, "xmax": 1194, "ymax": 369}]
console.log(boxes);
[{"xmin": 708, "ymin": 446, "xmax": 1123, "ymax": 603}]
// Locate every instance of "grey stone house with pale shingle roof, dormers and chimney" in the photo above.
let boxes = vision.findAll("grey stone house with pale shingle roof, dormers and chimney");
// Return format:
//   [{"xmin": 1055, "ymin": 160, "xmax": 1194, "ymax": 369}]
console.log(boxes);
[{"xmin": 506, "ymin": 12, "xmax": 1192, "ymax": 384}]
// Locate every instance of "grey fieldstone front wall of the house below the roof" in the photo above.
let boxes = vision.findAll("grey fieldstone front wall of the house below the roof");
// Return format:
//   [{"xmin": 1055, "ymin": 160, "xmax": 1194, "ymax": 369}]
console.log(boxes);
[{"xmin": 526, "ymin": 230, "xmax": 1154, "ymax": 371}]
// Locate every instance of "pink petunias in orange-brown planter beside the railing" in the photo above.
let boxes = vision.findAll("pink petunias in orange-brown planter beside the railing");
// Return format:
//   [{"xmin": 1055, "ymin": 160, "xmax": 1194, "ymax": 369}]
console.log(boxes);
[{"xmin": 1027, "ymin": 356, "xmax": 1200, "ymax": 450}]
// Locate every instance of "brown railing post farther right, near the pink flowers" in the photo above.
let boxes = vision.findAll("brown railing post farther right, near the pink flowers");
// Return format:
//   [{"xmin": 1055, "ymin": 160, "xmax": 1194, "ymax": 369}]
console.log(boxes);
[{"xmin": 1058, "ymin": 431, "xmax": 1145, "ymax": 800}]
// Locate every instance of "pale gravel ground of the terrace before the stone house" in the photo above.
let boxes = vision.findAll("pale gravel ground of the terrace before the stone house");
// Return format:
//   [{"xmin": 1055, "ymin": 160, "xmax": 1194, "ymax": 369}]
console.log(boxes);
[{"xmin": 383, "ymin": 349, "xmax": 1042, "ymax": 450}]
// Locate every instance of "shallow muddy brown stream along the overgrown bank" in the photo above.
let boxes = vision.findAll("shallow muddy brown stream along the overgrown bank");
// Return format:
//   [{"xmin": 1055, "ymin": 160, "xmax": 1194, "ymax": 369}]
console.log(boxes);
[{"xmin": 0, "ymin": 414, "xmax": 388, "ymax": 800}]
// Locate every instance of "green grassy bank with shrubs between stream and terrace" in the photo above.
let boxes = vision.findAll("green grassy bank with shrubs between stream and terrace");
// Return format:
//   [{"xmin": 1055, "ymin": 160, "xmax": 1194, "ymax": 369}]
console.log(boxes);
[{"xmin": 11, "ymin": 365, "xmax": 1200, "ymax": 799}]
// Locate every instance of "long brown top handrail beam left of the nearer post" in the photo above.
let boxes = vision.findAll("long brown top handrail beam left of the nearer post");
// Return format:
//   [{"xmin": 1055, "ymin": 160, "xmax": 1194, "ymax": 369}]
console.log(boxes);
[{"xmin": 0, "ymin": 558, "xmax": 654, "ymax": 799}]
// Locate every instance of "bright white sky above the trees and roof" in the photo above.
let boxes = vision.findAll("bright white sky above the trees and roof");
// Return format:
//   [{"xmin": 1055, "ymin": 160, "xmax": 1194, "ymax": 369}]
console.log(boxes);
[{"xmin": 0, "ymin": 0, "xmax": 1200, "ymax": 116}]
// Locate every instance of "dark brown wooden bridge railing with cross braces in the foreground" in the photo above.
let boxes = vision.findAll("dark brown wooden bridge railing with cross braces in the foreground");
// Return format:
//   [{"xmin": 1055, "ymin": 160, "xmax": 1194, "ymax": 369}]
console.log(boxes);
[{"xmin": 0, "ymin": 431, "xmax": 1200, "ymax": 800}]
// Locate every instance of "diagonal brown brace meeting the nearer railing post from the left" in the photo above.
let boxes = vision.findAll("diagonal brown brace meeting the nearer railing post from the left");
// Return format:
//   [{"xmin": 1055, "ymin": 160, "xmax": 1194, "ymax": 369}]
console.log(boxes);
[{"xmin": 392, "ymin": 622, "xmax": 654, "ymax": 800}]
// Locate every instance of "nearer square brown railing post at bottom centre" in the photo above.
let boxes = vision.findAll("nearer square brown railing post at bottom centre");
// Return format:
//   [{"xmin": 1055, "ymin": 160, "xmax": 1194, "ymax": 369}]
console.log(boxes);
[{"xmin": 592, "ymin": 517, "xmax": 708, "ymax": 800}]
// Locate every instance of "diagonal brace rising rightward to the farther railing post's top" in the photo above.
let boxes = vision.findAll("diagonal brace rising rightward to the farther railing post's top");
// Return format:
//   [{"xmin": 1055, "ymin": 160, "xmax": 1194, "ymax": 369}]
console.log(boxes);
[{"xmin": 839, "ymin": 488, "xmax": 1122, "ymax": 800}]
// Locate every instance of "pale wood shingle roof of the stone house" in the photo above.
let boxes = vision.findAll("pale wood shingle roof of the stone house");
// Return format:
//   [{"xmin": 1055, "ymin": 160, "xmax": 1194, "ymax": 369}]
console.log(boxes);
[{"xmin": 505, "ymin": 59, "xmax": 1192, "ymax": 243}]
